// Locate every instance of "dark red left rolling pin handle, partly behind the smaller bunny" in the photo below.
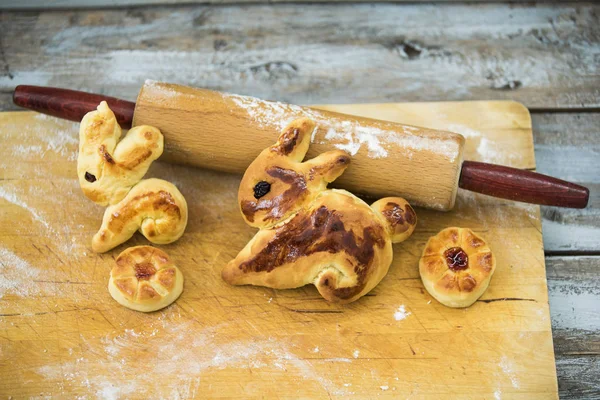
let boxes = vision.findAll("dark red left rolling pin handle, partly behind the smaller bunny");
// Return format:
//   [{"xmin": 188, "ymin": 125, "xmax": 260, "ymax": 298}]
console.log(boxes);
[{"xmin": 13, "ymin": 85, "xmax": 135, "ymax": 129}]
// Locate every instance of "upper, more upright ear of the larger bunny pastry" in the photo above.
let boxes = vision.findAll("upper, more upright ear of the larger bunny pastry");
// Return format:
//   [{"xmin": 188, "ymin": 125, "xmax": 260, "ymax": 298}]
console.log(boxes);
[{"xmin": 271, "ymin": 118, "xmax": 316, "ymax": 162}]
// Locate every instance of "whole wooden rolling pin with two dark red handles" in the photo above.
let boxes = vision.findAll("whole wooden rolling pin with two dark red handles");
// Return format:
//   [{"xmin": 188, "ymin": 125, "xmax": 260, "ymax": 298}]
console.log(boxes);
[{"xmin": 13, "ymin": 81, "xmax": 589, "ymax": 210}]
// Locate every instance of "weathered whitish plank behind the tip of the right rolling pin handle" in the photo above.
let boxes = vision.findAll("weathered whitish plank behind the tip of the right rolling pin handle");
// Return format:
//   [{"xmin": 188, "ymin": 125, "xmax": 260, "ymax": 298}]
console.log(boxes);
[{"xmin": 532, "ymin": 113, "xmax": 600, "ymax": 253}]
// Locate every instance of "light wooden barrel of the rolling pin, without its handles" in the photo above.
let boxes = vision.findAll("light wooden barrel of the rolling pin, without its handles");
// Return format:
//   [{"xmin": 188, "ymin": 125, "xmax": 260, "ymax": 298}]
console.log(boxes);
[{"xmin": 133, "ymin": 81, "xmax": 465, "ymax": 210}]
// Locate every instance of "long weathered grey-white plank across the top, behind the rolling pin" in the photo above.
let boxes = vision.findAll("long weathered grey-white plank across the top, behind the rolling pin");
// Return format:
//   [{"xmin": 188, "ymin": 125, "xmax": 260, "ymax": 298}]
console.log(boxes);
[{"xmin": 0, "ymin": 4, "xmax": 600, "ymax": 109}]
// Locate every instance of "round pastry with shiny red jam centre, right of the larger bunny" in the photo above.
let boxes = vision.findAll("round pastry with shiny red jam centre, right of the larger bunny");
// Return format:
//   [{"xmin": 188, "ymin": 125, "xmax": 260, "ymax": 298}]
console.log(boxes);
[{"xmin": 419, "ymin": 227, "xmax": 496, "ymax": 308}]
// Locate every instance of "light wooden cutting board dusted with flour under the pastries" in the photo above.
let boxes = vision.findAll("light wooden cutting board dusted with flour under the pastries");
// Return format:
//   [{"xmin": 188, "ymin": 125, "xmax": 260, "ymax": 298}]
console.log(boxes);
[{"xmin": 0, "ymin": 102, "xmax": 557, "ymax": 399}]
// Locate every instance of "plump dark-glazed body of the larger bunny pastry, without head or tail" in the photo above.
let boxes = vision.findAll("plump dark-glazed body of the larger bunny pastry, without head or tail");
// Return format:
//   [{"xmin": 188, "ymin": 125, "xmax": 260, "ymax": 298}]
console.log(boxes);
[{"xmin": 222, "ymin": 190, "xmax": 392, "ymax": 303}]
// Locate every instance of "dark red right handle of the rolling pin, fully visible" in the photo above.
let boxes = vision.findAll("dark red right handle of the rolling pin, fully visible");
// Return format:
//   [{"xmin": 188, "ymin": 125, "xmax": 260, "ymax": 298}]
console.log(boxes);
[{"xmin": 458, "ymin": 161, "xmax": 590, "ymax": 208}]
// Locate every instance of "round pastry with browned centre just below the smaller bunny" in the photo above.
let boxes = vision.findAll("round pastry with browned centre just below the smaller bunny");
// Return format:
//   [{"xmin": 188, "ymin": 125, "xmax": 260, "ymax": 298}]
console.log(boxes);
[{"xmin": 108, "ymin": 246, "xmax": 183, "ymax": 312}]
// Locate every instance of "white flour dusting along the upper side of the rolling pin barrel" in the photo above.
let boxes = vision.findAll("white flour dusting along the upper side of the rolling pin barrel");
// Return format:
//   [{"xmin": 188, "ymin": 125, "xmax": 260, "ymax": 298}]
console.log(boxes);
[{"xmin": 223, "ymin": 94, "xmax": 458, "ymax": 162}]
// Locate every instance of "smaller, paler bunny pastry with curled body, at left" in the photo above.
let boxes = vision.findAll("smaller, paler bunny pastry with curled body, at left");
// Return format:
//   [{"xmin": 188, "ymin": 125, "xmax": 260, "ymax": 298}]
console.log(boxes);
[{"xmin": 77, "ymin": 101, "xmax": 188, "ymax": 253}]
